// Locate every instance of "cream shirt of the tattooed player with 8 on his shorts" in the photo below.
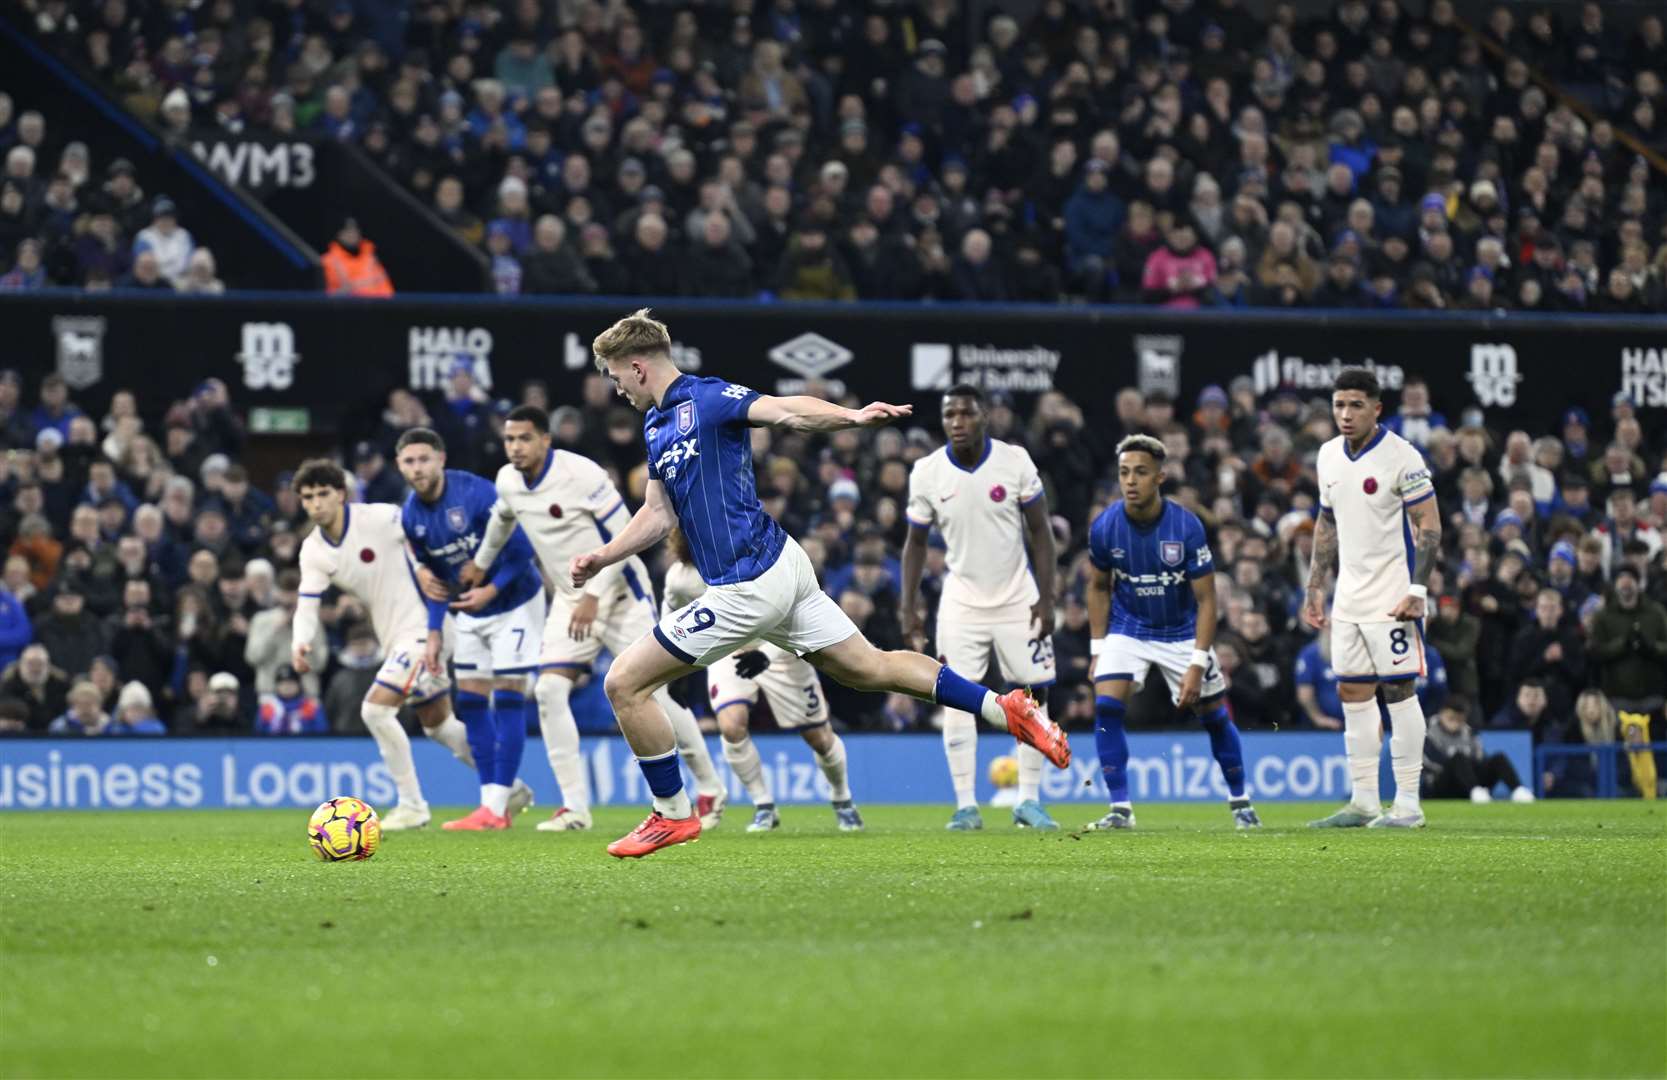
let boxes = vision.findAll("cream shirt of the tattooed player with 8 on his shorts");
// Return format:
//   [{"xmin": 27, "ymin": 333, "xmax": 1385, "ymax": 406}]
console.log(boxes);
[{"xmin": 1315, "ymin": 427, "xmax": 1435, "ymax": 623}]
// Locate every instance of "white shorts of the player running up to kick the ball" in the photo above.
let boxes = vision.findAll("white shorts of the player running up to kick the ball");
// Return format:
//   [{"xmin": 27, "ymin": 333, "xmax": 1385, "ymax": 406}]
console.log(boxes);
[{"xmin": 653, "ymin": 537, "xmax": 857, "ymax": 667}]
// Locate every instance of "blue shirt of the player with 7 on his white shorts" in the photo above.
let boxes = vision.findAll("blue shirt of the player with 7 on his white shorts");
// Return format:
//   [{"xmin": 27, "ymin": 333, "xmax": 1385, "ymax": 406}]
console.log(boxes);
[{"xmin": 400, "ymin": 468, "xmax": 543, "ymax": 618}]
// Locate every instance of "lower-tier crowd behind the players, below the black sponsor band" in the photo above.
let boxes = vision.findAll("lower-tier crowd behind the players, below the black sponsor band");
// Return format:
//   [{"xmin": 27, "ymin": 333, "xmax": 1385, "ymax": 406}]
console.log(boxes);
[{"xmin": 0, "ymin": 363, "xmax": 1667, "ymax": 793}]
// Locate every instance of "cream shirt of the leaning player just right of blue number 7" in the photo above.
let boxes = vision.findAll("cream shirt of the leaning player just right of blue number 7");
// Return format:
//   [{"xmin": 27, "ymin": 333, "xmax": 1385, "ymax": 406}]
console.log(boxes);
[{"xmin": 475, "ymin": 450, "xmax": 653, "ymax": 603}]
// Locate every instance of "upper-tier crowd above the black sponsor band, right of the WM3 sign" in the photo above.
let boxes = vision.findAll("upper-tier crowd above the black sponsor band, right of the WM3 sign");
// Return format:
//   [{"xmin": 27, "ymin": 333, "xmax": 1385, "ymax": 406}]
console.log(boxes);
[{"xmin": 0, "ymin": 0, "xmax": 1667, "ymax": 313}]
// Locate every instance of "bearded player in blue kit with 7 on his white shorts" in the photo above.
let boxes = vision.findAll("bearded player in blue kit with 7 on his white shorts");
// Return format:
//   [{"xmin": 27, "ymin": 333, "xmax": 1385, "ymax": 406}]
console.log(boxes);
[{"xmin": 395, "ymin": 428, "xmax": 545, "ymax": 832}]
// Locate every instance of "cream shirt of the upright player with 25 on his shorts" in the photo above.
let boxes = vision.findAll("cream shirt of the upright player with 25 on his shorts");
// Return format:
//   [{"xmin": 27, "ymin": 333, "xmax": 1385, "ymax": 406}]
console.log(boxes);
[{"xmin": 909, "ymin": 438, "xmax": 1042, "ymax": 615}]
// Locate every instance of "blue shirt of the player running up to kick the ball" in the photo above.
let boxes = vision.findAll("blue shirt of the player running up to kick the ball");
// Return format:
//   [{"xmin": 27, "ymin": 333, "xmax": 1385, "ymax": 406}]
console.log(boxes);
[{"xmin": 642, "ymin": 375, "xmax": 787, "ymax": 585}]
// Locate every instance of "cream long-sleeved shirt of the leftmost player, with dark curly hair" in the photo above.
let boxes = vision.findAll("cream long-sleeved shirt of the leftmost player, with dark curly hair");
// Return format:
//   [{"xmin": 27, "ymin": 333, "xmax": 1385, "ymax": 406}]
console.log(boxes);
[{"xmin": 297, "ymin": 503, "xmax": 428, "ymax": 646}]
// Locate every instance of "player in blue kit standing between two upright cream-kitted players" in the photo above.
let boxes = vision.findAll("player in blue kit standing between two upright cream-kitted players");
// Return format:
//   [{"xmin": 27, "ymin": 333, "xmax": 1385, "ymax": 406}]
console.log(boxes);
[{"xmin": 1087, "ymin": 435, "xmax": 1262, "ymax": 828}]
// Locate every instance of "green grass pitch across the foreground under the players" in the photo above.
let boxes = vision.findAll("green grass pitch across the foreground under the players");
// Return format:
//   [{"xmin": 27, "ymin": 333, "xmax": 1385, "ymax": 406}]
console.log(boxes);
[{"xmin": 0, "ymin": 802, "xmax": 1667, "ymax": 1078}]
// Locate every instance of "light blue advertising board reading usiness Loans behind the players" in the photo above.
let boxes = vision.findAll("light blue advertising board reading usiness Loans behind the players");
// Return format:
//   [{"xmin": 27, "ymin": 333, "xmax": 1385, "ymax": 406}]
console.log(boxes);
[{"xmin": 0, "ymin": 732, "xmax": 1532, "ymax": 810}]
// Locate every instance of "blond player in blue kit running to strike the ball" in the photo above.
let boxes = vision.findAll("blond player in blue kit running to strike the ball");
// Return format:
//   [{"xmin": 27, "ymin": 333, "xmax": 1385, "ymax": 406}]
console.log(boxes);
[{"xmin": 568, "ymin": 308, "xmax": 1070, "ymax": 858}]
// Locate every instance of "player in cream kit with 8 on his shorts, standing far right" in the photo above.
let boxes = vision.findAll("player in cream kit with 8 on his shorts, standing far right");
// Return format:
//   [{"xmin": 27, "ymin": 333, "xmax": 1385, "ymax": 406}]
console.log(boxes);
[{"xmin": 1302, "ymin": 368, "xmax": 1442, "ymax": 828}]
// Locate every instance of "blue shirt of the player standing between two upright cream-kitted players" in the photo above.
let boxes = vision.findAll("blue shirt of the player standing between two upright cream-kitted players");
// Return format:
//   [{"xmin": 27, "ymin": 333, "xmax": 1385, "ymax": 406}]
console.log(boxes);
[{"xmin": 1089, "ymin": 498, "xmax": 1215, "ymax": 642}]
